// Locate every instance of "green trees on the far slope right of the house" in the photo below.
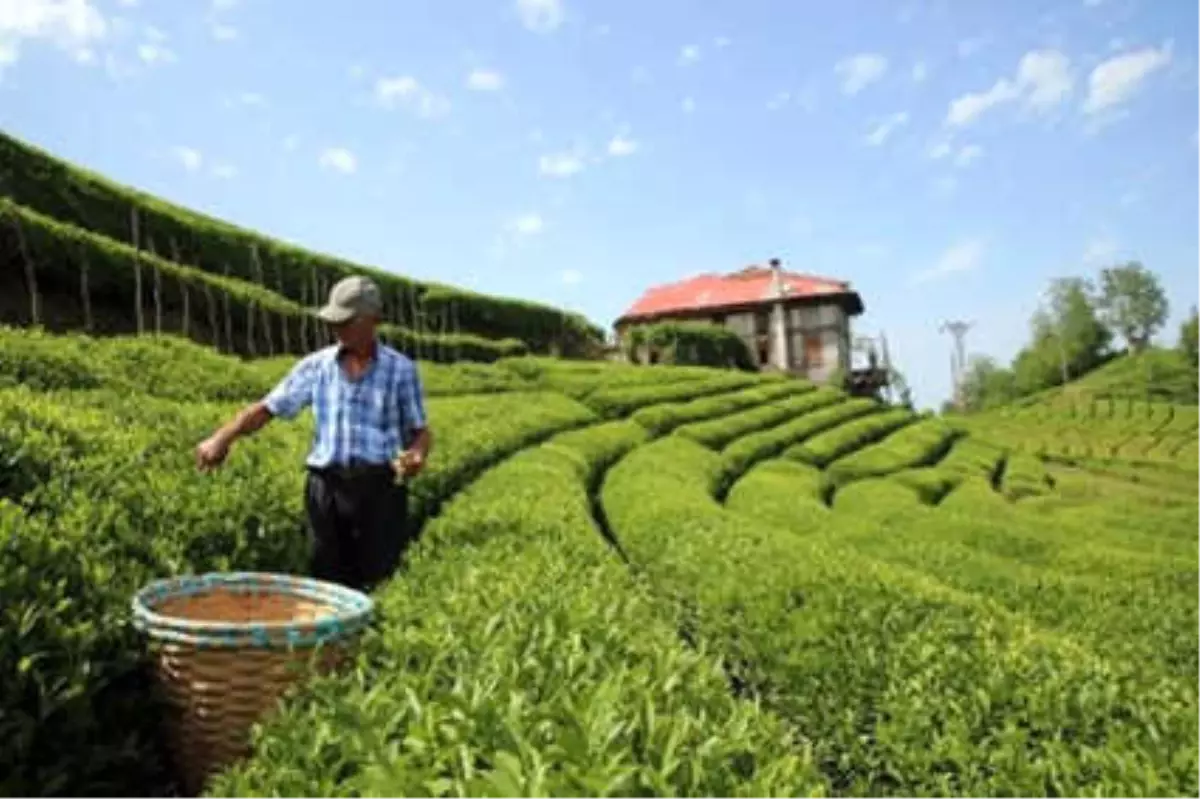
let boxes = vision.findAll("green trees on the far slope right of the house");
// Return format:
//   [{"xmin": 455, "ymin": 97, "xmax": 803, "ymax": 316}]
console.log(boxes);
[{"xmin": 959, "ymin": 262, "xmax": 1200, "ymax": 411}]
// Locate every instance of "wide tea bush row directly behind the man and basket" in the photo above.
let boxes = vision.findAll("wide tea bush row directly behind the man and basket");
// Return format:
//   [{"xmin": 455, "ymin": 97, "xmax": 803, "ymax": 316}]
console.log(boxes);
[{"xmin": 0, "ymin": 389, "xmax": 594, "ymax": 795}]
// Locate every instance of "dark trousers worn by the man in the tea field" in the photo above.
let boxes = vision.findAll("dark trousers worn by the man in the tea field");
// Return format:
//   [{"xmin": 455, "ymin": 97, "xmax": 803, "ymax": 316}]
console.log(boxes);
[{"xmin": 305, "ymin": 467, "xmax": 413, "ymax": 591}]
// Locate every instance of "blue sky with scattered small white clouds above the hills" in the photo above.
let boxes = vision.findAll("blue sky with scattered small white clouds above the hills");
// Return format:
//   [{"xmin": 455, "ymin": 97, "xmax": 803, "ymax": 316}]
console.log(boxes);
[{"xmin": 0, "ymin": 0, "xmax": 1200, "ymax": 405}]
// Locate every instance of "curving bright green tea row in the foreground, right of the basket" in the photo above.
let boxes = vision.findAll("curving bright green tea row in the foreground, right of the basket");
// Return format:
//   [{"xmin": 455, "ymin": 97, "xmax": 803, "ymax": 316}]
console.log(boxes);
[{"xmin": 212, "ymin": 421, "xmax": 818, "ymax": 797}]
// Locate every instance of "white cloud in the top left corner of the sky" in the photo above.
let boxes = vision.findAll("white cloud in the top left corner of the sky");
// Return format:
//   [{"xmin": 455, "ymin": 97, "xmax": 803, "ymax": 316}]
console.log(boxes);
[{"xmin": 0, "ymin": 0, "xmax": 108, "ymax": 65}]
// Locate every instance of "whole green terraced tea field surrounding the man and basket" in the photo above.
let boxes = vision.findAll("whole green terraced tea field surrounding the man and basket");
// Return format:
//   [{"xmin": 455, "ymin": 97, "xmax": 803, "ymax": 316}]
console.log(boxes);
[{"xmin": 0, "ymin": 331, "xmax": 1200, "ymax": 797}]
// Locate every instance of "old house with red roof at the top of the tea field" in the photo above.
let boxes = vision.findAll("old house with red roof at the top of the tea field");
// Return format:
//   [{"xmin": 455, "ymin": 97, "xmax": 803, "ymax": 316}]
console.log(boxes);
[{"xmin": 613, "ymin": 259, "xmax": 887, "ymax": 394}]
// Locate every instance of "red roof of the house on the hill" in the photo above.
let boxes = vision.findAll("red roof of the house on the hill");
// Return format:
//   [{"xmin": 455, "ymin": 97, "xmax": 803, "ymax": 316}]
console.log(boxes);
[{"xmin": 620, "ymin": 266, "xmax": 851, "ymax": 319}]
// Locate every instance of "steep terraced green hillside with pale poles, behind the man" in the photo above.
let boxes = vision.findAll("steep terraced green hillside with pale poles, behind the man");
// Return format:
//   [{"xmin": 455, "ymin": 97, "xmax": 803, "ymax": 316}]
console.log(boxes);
[{"xmin": 0, "ymin": 132, "xmax": 604, "ymax": 355}]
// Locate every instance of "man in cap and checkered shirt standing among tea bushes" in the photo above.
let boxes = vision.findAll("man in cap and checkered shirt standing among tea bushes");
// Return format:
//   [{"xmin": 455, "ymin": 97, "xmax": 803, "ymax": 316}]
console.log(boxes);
[{"xmin": 196, "ymin": 277, "xmax": 431, "ymax": 590}]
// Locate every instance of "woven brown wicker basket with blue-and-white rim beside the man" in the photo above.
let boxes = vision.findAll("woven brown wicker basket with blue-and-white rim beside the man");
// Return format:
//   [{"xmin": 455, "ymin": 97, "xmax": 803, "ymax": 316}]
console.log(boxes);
[{"xmin": 133, "ymin": 572, "xmax": 374, "ymax": 795}]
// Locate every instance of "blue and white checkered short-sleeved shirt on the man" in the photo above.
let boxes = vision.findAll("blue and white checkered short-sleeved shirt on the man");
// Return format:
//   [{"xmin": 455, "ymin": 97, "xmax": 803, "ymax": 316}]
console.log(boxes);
[{"xmin": 264, "ymin": 342, "xmax": 426, "ymax": 468}]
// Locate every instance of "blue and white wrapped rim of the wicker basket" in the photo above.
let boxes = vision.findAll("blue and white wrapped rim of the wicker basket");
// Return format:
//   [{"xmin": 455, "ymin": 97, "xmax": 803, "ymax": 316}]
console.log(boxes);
[{"xmin": 131, "ymin": 571, "xmax": 374, "ymax": 637}]
